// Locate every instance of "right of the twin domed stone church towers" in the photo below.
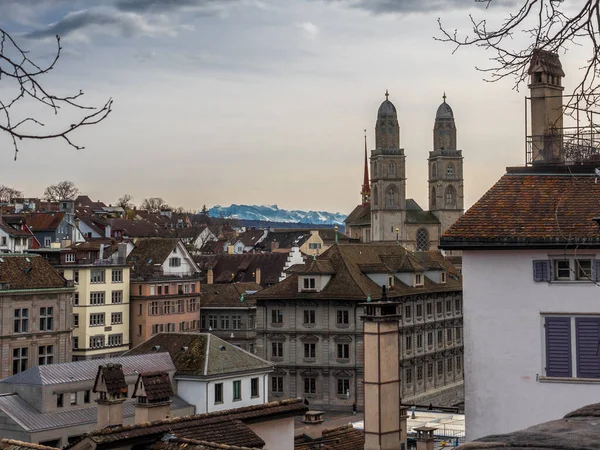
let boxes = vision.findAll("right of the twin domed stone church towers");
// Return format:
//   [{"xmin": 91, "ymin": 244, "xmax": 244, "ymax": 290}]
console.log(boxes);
[{"xmin": 429, "ymin": 93, "xmax": 464, "ymax": 233}]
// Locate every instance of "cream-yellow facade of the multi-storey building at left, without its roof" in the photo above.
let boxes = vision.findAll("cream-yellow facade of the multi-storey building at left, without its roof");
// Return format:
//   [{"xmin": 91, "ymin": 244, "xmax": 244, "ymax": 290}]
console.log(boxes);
[{"xmin": 63, "ymin": 265, "xmax": 131, "ymax": 359}]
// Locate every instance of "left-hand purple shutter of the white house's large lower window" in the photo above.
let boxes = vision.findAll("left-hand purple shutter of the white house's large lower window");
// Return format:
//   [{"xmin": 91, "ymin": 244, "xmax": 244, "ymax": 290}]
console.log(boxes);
[{"xmin": 544, "ymin": 317, "xmax": 571, "ymax": 378}]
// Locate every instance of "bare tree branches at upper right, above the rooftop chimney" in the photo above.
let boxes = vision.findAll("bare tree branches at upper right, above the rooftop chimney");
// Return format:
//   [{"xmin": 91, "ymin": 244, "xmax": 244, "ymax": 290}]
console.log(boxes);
[{"xmin": 436, "ymin": 0, "xmax": 600, "ymax": 108}]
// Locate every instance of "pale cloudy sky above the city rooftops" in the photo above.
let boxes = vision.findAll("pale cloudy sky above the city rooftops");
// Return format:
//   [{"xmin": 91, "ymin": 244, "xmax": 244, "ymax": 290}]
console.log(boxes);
[{"xmin": 0, "ymin": 0, "xmax": 582, "ymax": 213}]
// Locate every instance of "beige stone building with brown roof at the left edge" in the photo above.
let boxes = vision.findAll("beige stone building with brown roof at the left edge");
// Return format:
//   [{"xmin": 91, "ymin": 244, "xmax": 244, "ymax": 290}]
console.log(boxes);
[{"xmin": 0, "ymin": 254, "xmax": 74, "ymax": 378}]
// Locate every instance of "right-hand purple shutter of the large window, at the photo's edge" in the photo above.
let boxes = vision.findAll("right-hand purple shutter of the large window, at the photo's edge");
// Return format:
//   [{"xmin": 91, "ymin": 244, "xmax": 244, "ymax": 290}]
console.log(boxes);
[{"xmin": 575, "ymin": 317, "xmax": 600, "ymax": 378}]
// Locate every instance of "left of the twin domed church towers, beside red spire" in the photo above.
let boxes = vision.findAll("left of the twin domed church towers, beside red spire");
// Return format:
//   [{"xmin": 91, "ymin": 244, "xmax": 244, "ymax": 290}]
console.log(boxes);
[{"xmin": 371, "ymin": 91, "xmax": 406, "ymax": 241}]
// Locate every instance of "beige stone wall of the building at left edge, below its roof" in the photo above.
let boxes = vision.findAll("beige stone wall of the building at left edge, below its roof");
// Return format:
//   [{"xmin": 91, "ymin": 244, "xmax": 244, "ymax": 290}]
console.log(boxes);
[{"xmin": 0, "ymin": 288, "xmax": 73, "ymax": 378}]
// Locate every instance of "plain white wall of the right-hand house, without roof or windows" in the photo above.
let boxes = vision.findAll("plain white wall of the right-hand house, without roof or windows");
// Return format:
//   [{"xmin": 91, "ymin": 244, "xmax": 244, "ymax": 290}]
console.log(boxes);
[{"xmin": 463, "ymin": 249, "xmax": 600, "ymax": 440}]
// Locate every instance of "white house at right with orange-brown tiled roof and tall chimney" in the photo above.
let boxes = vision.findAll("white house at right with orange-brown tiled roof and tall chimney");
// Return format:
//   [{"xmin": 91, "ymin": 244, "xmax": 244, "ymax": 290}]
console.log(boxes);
[{"xmin": 440, "ymin": 52, "xmax": 600, "ymax": 440}]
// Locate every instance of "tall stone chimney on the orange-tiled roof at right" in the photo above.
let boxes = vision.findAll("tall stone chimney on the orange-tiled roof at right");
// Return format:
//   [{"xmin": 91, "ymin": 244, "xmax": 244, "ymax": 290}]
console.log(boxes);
[{"xmin": 528, "ymin": 50, "xmax": 565, "ymax": 164}]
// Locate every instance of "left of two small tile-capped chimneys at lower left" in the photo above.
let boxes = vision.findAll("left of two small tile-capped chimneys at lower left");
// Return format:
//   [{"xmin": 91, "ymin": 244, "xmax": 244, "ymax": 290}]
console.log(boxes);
[{"xmin": 92, "ymin": 364, "xmax": 127, "ymax": 429}]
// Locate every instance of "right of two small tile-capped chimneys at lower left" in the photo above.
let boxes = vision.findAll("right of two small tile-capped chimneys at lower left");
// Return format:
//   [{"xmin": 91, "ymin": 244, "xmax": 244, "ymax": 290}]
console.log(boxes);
[{"xmin": 132, "ymin": 372, "xmax": 175, "ymax": 424}]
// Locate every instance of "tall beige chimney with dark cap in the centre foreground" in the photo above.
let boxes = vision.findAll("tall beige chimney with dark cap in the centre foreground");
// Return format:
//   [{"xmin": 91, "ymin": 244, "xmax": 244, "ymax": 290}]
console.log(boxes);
[{"xmin": 362, "ymin": 286, "xmax": 407, "ymax": 450}]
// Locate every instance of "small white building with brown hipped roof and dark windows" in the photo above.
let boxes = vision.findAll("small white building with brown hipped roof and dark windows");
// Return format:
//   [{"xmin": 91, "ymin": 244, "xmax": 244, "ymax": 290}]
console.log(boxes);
[{"xmin": 126, "ymin": 333, "xmax": 274, "ymax": 414}]
